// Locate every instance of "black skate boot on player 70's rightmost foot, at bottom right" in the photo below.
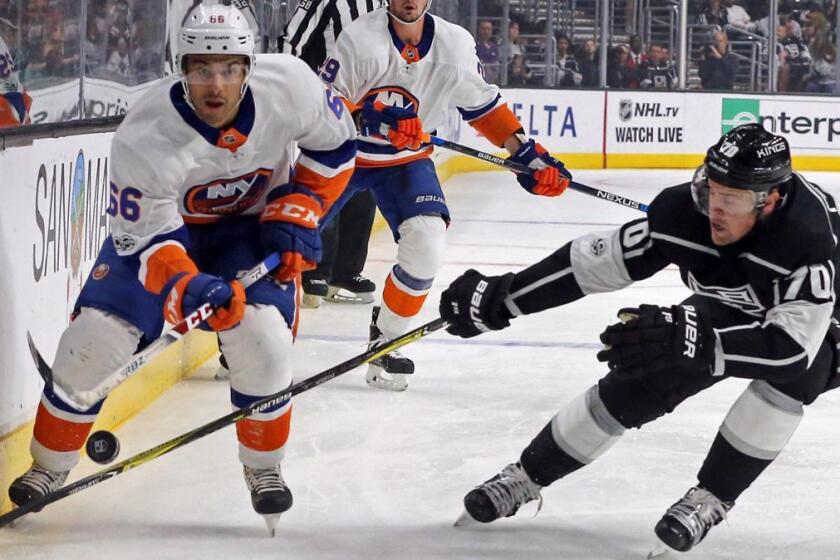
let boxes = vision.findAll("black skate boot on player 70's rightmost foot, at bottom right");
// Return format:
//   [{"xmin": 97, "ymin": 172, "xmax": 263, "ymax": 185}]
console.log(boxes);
[{"xmin": 655, "ymin": 486, "xmax": 735, "ymax": 552}]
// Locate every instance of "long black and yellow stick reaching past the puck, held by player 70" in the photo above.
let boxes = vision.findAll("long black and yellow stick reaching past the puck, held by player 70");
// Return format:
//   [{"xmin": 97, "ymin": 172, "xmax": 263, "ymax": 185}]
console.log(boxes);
[{"xmin": 0, "ymin": 318, "xmax": 448, "ymax": 527}]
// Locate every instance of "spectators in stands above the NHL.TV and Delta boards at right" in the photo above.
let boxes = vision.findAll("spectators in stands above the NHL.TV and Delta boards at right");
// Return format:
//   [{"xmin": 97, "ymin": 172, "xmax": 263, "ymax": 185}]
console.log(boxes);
[{"xmin": 475, "ymin": 0, "xmax": 837, "ymax": 93}]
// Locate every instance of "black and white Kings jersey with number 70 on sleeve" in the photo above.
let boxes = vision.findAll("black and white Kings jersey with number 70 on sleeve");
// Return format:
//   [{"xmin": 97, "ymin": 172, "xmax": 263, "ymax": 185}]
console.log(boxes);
[{"xmin": 506, "ymin": 175, "xmax": 840, "ymax": 380}]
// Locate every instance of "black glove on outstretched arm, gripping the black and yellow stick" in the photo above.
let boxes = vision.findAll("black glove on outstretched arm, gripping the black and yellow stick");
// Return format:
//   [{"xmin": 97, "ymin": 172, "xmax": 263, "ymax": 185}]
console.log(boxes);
[{"xmin": 440, "ymin": 269, "xmax": 513, "ymax": 338}]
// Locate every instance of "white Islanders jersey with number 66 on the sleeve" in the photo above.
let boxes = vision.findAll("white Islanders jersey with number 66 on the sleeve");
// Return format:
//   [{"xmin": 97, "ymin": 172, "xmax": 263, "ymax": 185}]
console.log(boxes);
[{"xmin": 108, "ymin": 54, "xmax": 355, "ymax": 293}]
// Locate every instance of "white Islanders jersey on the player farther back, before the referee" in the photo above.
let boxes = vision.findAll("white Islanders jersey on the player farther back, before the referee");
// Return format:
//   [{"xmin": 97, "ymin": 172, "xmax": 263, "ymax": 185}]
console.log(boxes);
[{"xmin": 321, "ymin": 10, "xmax": 520, "ymax": 167}]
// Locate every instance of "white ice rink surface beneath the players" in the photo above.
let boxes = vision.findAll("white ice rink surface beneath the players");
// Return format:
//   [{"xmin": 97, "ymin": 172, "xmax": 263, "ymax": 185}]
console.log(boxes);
[{"xmin": 0, "ymin": 170, "xmax": 840, "ymax": 560}]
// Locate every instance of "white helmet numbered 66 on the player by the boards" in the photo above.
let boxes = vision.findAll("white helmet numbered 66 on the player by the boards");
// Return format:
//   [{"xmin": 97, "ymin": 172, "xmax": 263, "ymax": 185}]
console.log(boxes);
[{"xmin": 175, "ymin": 4, "xmax": 257, "ymax": 102}]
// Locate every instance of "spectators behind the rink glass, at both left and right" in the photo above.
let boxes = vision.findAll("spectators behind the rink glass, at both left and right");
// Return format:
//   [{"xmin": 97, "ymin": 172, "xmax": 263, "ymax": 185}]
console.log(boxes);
[{"xmin": 0, "ymin": 0, "xmax": 838, "ymax": 130}]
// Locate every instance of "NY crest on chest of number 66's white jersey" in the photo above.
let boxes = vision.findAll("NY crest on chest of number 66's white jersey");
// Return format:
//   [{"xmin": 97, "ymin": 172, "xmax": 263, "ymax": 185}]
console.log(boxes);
[{"xmin": 184, "ymin": 169, "xmax": 272, "ymax": 217}]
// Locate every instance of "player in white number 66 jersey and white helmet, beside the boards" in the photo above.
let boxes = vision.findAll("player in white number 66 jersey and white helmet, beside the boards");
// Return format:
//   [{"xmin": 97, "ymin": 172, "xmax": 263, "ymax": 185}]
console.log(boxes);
[{"xmin": 9, "ymin": 5, "xmax": 356, "ymax": 532}]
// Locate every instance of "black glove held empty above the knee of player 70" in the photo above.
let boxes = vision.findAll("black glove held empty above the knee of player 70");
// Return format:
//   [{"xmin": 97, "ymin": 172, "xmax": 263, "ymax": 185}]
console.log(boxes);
[{"xmin": 598, "ymin": 304, "xmax": 715, "ymax": 377}]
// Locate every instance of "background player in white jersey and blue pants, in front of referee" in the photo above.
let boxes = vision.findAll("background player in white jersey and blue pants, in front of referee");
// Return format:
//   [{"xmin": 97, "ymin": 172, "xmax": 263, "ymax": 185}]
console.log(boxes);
[{"xmin": 321, "ymin": 0, "xmax": 571, "ymax": 391}]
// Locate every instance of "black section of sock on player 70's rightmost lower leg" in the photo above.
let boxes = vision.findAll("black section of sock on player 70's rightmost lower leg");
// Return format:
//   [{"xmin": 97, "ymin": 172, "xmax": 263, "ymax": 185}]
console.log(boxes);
[{"xmin": 697, "ymin": 432, "xmax": 773, "ymax": 502}]
